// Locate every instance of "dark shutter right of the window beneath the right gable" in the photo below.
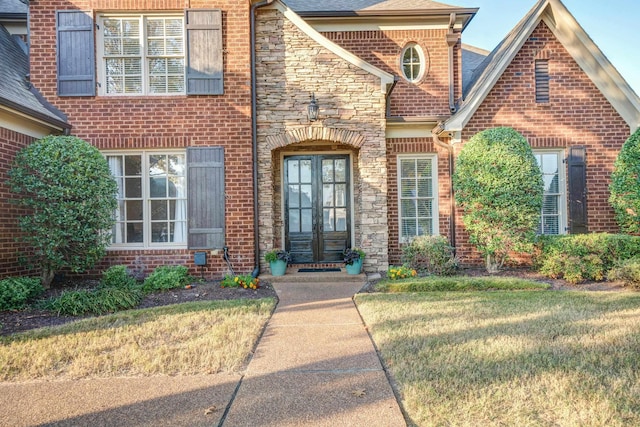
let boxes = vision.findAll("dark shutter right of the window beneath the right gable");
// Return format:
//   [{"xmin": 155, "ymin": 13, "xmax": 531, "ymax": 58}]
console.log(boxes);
[{"xmin": 567, "ymin": 146, "xmax": 589, "ymax": 234}]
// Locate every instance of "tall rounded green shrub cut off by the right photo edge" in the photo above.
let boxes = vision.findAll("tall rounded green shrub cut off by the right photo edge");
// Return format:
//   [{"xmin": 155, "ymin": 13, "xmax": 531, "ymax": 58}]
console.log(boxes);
[{"xmin": 609, "ymin": 129, "xmax": 640, "ymax": 233}]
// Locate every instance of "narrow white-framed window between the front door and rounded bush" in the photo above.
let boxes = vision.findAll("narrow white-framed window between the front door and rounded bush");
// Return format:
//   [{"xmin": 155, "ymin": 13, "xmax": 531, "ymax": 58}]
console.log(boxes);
[{"xmin": 398, "ymin": 155, "xmax": 438, "ymax": 242}]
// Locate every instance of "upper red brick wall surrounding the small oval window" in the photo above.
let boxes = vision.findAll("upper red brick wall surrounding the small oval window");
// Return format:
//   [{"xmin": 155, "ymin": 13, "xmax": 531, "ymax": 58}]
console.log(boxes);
[{"xmin": 322, "ymin": 30, "xmax": 461, "ymax": 117}]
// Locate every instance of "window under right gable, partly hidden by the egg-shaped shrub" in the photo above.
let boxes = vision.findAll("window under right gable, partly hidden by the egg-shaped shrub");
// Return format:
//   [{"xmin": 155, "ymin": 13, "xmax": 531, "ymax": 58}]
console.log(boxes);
[{"xmin": 534, "ymin": 150, "xmax": 567, "ymax": 234}]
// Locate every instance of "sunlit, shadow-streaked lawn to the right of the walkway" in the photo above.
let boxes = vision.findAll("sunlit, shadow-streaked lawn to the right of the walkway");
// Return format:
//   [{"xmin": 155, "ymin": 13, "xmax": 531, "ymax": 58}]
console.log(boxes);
[{"xmin": 356, "ymin": 291, "xmax": 640, "ymax": 427}]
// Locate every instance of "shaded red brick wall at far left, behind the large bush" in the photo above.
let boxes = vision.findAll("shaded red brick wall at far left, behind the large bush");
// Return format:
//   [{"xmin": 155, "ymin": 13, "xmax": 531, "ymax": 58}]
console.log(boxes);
[{"xmin": 0, "ymin": 127, "xmax": 33, "ymax": 278}]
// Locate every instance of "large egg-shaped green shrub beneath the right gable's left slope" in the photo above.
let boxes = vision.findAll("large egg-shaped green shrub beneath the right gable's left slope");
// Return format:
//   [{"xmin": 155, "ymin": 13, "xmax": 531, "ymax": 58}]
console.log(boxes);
[{"xmin": 453, "ymin": 128, "xmax": 544, "ymax": 272}]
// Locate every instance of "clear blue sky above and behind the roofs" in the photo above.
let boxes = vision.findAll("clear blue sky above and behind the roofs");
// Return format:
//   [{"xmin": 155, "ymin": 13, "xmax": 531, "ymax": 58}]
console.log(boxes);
[{"xmin": 450, "ymin": 0, "xmax": 640, "ymax": 94}]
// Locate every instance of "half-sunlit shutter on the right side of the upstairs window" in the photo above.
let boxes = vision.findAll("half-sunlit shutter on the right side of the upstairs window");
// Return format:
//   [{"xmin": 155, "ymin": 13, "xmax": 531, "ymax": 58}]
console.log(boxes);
[{"xmin": 184, "ymin": 9, "xmax": 224, "ymax": 95}]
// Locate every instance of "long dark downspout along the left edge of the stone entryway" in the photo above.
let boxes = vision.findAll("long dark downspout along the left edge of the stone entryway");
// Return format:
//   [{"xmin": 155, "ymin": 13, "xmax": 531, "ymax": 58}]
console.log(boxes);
[{"xmin": 249, "ymin": 0, "xmax": 273, "ymax": 277}]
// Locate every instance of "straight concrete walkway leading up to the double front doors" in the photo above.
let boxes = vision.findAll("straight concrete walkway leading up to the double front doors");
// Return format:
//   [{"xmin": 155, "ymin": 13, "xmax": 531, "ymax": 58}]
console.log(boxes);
[{"xmin": 223, "ymin": 281, "xmax": 406, "ymax": 427}]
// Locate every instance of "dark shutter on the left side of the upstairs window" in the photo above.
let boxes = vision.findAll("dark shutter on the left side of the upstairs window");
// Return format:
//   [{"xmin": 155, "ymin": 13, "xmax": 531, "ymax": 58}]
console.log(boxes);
[{"xmin": 56, "ymin": 10, "xmax": 96, "ymax": 96}]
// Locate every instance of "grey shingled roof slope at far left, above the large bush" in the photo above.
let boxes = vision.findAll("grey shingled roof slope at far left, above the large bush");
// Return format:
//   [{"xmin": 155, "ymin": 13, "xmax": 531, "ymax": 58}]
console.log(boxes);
[{"xmin": 0, "ymin": 25, "xmax": 71, "ymax": 130}]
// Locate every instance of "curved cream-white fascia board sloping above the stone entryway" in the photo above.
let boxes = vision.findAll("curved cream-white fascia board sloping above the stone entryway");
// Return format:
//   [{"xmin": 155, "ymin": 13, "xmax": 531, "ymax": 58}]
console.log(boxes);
[{"xmin": 272, "ymin": 0, "xmax": 394, "ymax": 93}]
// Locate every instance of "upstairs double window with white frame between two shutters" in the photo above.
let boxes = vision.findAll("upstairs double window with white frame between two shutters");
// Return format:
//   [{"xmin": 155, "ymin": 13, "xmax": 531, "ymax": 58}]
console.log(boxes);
[{"xmin": 98, "ymin": 15, "xmax": 185, "ymax": 95}]
